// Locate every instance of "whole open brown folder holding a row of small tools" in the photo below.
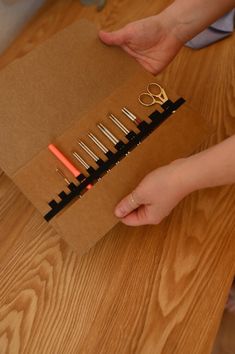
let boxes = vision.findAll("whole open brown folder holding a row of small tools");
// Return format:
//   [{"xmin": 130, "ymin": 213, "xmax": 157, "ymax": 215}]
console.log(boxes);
[{"xmin": 0, "ymin": 20, "xmax": 212, "ymax": 254}]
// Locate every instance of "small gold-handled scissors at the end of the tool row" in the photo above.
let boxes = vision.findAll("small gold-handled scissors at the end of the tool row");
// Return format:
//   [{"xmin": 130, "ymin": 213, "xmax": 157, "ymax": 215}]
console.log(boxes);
[{"xmin": 139, "ymin": 82, "xmax": 169, "ymax": 107}]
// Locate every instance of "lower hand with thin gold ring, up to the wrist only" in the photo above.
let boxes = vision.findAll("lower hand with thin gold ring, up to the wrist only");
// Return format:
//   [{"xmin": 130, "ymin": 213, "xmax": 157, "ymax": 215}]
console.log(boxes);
[{"xmin": 115, "ymin": 159, "xmax": 192, "ymax": 226}]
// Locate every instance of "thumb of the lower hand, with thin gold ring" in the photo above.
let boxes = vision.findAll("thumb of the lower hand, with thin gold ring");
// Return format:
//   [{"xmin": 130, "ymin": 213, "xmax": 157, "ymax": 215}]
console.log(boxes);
[{"xmin": 115, "ymin": 190, "xmax": 141, "ymax": 218}]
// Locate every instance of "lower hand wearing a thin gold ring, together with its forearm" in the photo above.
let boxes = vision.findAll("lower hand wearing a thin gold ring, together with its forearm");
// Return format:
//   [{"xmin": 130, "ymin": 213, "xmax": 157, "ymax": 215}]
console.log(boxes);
[{"xmin": 115, "ymin": 135, "xmax": 235, "ymax": 226}]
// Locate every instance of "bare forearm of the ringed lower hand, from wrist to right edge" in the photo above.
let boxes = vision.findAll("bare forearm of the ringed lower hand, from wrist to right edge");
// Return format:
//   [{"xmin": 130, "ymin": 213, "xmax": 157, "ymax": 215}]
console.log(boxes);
[{"xmin": 177, "ymin": 135, "xmax": 235, "ymax": 193}]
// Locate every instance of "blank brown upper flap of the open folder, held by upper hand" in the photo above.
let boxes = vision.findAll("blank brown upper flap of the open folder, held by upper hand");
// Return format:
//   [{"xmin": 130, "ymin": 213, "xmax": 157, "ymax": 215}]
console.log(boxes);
[{"xmin": 0, "ymin": 20, "xmax": 138, "ymax": 177}]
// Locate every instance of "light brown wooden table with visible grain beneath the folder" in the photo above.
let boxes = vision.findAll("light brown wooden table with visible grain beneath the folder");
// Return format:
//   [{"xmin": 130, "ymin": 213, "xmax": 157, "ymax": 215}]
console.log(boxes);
[{"xmin": 0, "ymin": 0, "xmax": 235, "ymax": 354}]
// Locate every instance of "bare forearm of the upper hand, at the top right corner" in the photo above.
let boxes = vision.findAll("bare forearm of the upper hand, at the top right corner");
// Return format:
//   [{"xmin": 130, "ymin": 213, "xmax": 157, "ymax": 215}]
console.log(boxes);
[{"xmin": 162, "ymin": 0, "xmax": 235, "ymax": 43}]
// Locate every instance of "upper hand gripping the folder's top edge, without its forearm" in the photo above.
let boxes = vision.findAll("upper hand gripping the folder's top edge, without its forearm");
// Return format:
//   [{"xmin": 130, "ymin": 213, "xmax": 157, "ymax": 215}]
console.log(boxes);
[{"xmin": 99, "ymin": 14, "xmax": 184, "ymax": 75}]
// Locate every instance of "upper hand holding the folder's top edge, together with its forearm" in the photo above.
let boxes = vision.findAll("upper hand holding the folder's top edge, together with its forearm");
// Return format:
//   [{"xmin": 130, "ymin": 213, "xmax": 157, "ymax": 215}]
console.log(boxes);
[{"xmin": 99, "ymin": 0, "xmax": 234, "ymax": 74}]
